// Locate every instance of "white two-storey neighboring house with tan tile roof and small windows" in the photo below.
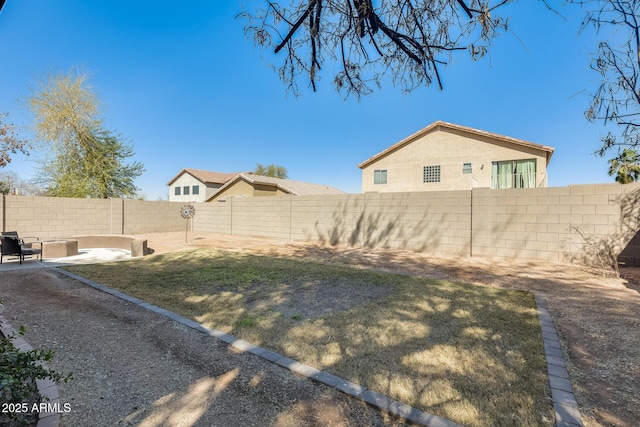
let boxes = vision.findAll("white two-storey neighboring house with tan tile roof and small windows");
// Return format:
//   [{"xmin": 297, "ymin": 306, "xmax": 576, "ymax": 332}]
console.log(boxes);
[{"xmin": 167, "ymin": 168, "xmax": 244, "ymax": 202}]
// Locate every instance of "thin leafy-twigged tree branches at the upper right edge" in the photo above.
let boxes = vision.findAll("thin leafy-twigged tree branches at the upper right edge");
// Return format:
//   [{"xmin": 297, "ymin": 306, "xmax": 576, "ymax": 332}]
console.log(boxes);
[{"xmin": 571, "ymin": 0, "xmax": 640, "ymax": 156}]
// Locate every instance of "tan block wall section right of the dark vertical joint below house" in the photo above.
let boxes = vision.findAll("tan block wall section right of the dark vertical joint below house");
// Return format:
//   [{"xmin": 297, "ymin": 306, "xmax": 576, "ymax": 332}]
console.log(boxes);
[{"xmin": 472, "ymin": 184, "xmax": 640, "ymax": 264}]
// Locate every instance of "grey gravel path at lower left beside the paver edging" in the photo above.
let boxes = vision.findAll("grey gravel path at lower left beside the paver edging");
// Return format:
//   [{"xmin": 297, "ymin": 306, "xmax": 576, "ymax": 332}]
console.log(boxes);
[{"xmin": 0, "ymin": 269, "xmax": 404, "ymax": 426}]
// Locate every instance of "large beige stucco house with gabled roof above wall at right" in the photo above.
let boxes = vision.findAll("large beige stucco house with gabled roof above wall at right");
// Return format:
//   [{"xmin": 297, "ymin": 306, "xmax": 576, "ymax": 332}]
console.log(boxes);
[{"xmin": 358, "ymin": 121, "xmax": 554, "ymax": 192}]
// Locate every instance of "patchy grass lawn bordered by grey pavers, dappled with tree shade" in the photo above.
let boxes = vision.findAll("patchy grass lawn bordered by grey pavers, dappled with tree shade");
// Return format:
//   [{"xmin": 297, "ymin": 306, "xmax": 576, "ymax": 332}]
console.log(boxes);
[{"xmin": 68, "ymin": 248, "xmax": 554, "ymax": 426}]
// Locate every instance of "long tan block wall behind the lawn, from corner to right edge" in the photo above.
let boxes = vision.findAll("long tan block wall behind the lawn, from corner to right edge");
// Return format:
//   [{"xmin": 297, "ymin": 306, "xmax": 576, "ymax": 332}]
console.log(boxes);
[{"xmin": 196, "ymin": 184, "xmax": 640, "ymax": 265}]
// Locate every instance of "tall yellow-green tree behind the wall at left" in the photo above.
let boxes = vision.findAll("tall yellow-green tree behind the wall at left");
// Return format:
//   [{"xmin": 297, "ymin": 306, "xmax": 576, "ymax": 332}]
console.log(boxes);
[{"xmin": 29, "ymin": 70, "xmax": 144, "ymax": 198}]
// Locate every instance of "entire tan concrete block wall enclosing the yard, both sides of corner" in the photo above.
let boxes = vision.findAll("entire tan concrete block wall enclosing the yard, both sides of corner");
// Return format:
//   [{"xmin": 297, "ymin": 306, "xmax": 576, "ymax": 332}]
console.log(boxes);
[{"xmin": 0, "ymin": 184, "xmax": 640, "ymax": 265}]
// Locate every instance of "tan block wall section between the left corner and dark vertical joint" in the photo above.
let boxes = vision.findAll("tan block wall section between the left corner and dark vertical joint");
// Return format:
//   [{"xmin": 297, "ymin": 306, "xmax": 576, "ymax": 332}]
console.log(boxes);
[{"xmin": 195, "ymin": 191, "xmax": 471, "ymax": 256}]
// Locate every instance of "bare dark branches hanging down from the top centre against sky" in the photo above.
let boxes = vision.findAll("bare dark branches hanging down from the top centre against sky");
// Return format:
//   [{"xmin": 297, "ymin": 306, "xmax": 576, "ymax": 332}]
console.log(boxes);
[{"xmin": 239, "ymin": 0, "xmax": 516, "ymax": 98}]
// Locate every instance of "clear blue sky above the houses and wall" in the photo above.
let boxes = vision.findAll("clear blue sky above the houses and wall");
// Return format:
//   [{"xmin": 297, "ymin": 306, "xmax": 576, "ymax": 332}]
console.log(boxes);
[{"xmin": 0, "ymin": 0, "xmax": 614, "ymax": 200}]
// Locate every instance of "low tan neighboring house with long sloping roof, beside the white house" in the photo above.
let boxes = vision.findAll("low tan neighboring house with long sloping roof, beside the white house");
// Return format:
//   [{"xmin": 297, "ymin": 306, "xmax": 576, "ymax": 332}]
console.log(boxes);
[{"xmin": 205, "ymin": 173, "xmax": 344, "ymax": 202}]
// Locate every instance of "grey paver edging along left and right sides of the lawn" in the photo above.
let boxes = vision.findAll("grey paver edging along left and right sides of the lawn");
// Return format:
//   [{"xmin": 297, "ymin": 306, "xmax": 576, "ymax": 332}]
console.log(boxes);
[{"xmin": 56, "ymin": 267, "xmax": 583, "ymax": 427}]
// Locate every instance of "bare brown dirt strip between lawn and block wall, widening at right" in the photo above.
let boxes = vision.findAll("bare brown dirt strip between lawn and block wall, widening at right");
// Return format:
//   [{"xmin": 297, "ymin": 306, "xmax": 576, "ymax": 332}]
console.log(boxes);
[{"xmin": 136, "ymin": 232, "xmax": 640, "ymax": 427}]
